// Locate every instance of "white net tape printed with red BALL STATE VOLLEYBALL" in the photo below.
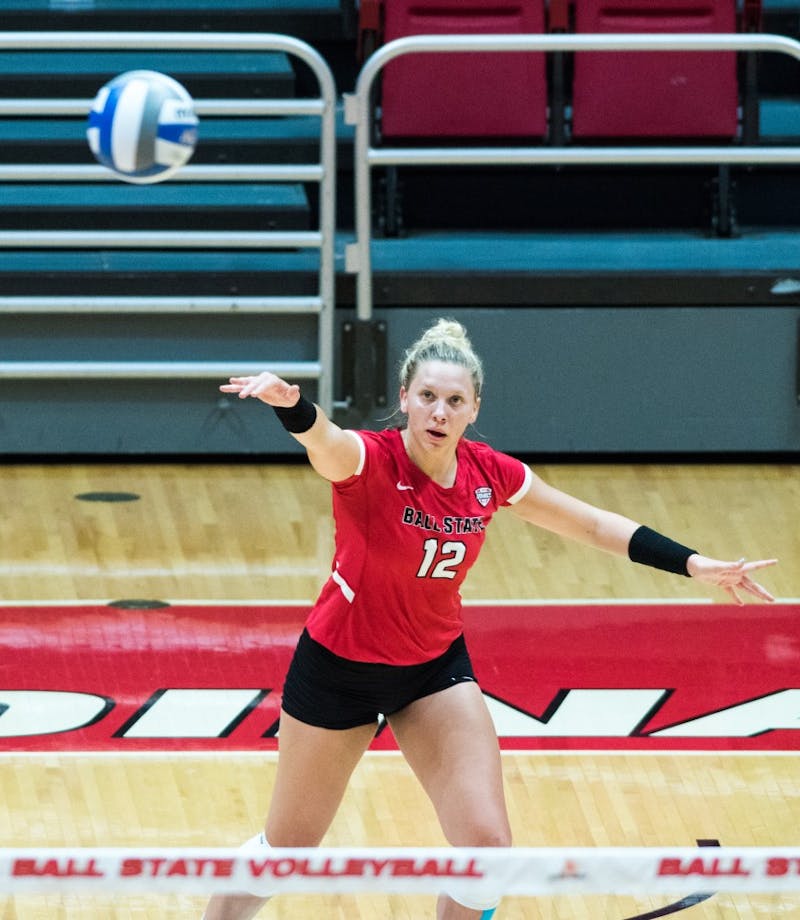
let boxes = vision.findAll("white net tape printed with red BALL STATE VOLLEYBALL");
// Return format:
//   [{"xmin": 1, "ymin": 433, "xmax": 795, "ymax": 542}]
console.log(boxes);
[{"xmin": 0, "ymin": 847, "xmax": 800, "ymax": 896}]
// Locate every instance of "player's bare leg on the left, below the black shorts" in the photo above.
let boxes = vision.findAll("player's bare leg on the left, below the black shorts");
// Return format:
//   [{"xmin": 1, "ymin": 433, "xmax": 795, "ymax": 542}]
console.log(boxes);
[{"xmin": 203, "ymin": 712, "xmax": 376, "ymax": 920}]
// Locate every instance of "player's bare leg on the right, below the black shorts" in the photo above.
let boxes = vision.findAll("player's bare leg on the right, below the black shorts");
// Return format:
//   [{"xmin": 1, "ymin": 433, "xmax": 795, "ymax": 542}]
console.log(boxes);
[{"xmin": 389, "ymin": 683, "xmax": 511, "ymax": 920}]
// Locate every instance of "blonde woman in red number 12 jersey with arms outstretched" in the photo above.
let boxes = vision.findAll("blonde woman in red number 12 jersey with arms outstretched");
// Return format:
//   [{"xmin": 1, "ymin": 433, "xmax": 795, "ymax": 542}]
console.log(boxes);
[{"xmin": 205, "ymin": 319, "xmax": 775, "ymax": 920}]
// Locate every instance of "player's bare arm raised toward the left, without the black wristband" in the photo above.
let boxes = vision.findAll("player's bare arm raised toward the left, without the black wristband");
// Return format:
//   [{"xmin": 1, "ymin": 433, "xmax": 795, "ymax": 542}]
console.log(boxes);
[{"xmin": 220, "ymin": 371, "xmax": 361, "ymax": 482}]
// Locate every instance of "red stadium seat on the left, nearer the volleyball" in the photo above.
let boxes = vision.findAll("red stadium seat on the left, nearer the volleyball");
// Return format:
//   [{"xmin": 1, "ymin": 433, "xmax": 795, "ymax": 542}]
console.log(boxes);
[{"xmin": 381, "ymin": 0, "xmax": 547, "ymax": 138}]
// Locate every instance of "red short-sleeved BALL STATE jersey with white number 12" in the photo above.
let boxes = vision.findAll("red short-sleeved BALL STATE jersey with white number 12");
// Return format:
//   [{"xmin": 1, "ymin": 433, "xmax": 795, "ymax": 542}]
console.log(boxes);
[{"xmin": 306, "ymin": 429, "xmax": 532, "ymax": 665}]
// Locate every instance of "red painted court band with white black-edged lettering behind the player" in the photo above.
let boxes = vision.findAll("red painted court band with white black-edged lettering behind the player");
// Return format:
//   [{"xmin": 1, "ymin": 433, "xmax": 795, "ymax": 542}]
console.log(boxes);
[{"xmin": 0, "ymin": 603, "xmax": 800, "ymax": 751}]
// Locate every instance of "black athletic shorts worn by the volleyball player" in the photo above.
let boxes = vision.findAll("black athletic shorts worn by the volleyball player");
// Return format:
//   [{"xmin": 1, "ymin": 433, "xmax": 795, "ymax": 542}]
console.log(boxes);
[{"xmin": 283, "ymin": 630, "xmax": 475, "ymax": 729}]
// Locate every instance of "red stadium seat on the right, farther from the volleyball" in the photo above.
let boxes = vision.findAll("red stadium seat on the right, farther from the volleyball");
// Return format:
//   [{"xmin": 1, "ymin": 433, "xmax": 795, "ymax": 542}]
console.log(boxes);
[{"xmin": 572, "ymin": 0, "xmax": 739, "ymax": 138}]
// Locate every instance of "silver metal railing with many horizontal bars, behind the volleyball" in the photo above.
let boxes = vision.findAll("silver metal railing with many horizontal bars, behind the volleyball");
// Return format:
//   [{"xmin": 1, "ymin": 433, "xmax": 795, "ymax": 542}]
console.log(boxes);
[{"xmin": 0, "ymin": 31, "xmax": 337, "ymax": 411}]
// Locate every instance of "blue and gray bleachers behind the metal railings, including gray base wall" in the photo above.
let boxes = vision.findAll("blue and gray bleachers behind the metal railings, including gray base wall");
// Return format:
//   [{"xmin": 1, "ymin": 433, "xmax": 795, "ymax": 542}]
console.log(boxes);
[{"xmin": 0, "ymin": 0, "xmax": 800, "ymax": 459}]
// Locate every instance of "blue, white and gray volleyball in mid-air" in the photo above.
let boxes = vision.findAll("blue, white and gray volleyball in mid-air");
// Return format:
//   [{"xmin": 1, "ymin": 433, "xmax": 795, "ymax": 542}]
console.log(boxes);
[{"xmin": 86, "ymin": 70, "xmax": 198, "ymax": 184}]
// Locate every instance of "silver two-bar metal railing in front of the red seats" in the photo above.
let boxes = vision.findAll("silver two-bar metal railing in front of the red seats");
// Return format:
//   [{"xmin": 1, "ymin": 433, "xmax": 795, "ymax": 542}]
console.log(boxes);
[{"xmin": 345, "ymin": 33, "xmax": 800, "ymax": 322}]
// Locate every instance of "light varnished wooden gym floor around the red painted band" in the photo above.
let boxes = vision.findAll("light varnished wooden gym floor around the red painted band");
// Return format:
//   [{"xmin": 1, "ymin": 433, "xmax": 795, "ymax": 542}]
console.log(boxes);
[{"xmin": 0, "ymin": 464, "xmax": 800, "ymax": 920}]
